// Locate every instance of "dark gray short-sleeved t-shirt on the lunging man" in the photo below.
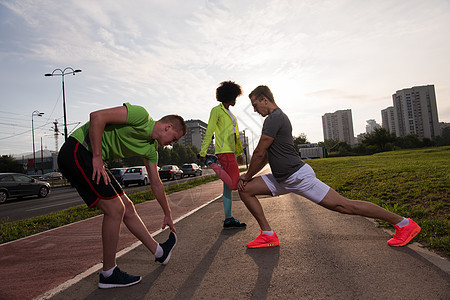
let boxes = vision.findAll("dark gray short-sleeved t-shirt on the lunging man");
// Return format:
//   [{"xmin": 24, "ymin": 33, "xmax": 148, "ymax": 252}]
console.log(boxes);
[{"xmin": 262, "ymin": 108, "xmax": 305, "ymax": 182}]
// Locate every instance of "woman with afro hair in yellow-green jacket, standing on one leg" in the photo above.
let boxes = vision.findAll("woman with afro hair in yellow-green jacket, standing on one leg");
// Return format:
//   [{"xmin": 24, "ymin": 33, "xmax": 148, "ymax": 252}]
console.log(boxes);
[{"xmin": 199, "ymin": 81, "xmax": 246, "ymax": 229}]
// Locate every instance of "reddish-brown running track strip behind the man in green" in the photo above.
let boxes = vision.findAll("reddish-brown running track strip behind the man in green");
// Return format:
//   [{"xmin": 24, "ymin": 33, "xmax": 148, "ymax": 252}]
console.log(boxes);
[{"xmin": 0, "ymin": 181, "xmax": 222, "ymax": 300}]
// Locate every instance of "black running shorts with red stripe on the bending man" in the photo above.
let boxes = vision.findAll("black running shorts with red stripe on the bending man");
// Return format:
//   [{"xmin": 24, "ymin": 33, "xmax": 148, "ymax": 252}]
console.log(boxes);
[{"xmin": 58, "ymin": 137, "xmax": 124, "ymax": 207}]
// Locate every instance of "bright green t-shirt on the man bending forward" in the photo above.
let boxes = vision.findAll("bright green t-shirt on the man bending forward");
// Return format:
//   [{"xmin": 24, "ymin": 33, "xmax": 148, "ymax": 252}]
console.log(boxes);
[{"xmin": 71, "ymin": 103, "xmax": 158, "ymax": 164}]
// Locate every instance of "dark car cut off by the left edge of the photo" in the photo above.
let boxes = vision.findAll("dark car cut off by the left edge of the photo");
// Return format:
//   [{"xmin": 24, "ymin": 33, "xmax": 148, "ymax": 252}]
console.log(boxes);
[{"xmin": 0, "ymin": 173, "xmax": 50, "ymax": 203}]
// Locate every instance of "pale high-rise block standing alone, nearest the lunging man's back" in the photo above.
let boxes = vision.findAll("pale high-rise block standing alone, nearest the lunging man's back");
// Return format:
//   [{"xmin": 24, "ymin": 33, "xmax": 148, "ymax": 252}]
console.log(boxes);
[{"xmin": 322, "ymin": 109, "xmax": 355, "ymax": 145}]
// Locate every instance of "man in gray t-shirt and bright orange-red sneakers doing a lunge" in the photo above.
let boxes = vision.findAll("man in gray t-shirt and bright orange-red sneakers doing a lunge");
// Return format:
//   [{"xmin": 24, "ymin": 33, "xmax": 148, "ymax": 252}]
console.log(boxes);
[{"xmin": 238, "ymin": 86, "xmax": 420, "ymax": 248}]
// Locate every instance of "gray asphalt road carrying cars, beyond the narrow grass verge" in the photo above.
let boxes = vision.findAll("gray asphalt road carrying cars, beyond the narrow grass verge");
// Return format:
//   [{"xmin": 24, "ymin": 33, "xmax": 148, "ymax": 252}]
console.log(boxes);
[{"xmin": 0, "ymin": 169, "xmax": 214, "ymax": 222}]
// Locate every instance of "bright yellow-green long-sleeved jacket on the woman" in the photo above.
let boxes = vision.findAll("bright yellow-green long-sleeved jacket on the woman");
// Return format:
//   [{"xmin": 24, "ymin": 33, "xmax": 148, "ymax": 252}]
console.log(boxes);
[{"xmin": 200, "ymin": 103, "xmax": 244, "ymax": 156}]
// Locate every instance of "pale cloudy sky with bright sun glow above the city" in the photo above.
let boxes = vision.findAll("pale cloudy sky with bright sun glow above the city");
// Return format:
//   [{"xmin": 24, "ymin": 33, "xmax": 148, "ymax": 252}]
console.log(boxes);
[{"xmin": 0, "ymin": 0, "xmax": 450, "ymax": 155}]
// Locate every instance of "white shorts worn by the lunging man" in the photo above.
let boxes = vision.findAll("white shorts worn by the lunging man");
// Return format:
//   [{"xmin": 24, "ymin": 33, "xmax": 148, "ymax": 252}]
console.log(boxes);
[{"xmin": 261, "ymin": 164, "xmax": 330, "ymax": 203}]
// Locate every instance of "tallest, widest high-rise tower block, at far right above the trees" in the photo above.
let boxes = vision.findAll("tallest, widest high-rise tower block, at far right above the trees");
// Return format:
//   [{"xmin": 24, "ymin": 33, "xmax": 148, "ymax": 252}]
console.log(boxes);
[{"xmin": 392, "ymin": 85, "xmax": 440, "ymax": 138}]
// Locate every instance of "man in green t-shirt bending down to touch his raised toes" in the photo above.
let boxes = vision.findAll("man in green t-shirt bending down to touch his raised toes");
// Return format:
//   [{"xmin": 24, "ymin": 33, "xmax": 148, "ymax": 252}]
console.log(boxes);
[{"xmin": 58, "ymin": 103, "xmax": 186, "ymax": 288}]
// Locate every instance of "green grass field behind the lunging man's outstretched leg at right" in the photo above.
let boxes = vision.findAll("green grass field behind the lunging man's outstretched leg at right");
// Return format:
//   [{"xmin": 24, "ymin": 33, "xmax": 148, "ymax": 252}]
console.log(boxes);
[{"xmin": 307, "ymin": 147, "xmax": 450, "ymax": 257}]
